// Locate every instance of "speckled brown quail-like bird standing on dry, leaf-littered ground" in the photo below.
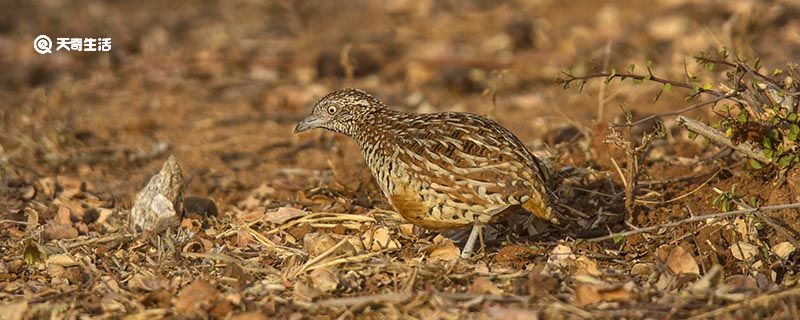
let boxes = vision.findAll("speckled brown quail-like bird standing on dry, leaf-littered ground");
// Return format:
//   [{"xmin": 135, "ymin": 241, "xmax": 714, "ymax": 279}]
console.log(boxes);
[{"xmin": 294, "ymin": 88, "xmax": 558, "ymax": 258}]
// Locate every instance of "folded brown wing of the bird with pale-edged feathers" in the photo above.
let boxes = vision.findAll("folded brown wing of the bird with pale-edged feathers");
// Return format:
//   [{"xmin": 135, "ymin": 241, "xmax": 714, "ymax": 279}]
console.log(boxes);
[{"xmin": 394, "ymin": 113, "xmax": 547, "ymax": 220}]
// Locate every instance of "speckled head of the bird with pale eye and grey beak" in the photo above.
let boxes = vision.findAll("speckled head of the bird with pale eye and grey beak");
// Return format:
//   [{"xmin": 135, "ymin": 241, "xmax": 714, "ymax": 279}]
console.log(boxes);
[{"xmin": 294, "ymin": 88, "xmax": 386, "ymax": 137}]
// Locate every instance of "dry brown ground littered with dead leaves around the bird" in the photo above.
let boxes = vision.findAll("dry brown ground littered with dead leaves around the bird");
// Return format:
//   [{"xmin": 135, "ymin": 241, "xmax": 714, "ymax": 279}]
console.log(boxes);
[{"xmin": 0, "ymin": 0, "xmax": 800, "ymax": 319}]
